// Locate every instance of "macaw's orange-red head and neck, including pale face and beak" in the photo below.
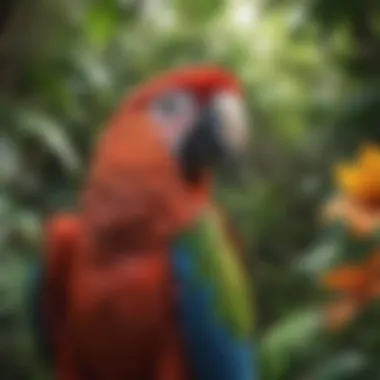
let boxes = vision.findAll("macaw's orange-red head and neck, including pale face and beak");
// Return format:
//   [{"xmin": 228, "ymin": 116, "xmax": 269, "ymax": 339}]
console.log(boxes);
[{"xmin": 82, "ymin": 67, "xmax": 247, "ymax": 246}]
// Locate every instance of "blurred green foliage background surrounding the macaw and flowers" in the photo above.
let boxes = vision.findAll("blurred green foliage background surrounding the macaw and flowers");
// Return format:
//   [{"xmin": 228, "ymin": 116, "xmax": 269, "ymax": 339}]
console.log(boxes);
[{"xmin": 0, "ymin": 0, "xmax": 380, "ymax": 380}]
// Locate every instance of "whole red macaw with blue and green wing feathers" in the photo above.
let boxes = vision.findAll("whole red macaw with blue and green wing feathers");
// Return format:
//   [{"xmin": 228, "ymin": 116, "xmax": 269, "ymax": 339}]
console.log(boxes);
[{"xmin": 28, "ymin": 65, "xmax": 259, "ymax": 380}]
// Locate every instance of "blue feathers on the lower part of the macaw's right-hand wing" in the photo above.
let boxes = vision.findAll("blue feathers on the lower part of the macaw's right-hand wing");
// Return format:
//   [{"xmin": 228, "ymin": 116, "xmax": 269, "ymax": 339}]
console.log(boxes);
[{"xmin": 173, "ymin": 247, "xmax": 258, "ymax": 380}]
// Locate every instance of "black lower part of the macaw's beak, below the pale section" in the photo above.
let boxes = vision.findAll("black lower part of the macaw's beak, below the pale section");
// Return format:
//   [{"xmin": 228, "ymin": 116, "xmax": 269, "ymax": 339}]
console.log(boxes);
[{"xmin": 180, "ymin": 107, "xmax": 226, "ymax": 183}]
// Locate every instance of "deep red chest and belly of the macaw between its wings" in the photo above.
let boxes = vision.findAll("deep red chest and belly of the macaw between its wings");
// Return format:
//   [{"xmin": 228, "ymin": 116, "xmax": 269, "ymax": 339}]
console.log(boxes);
[{"xmin": 67, "ymin": 235, "xmax": 175, "ymax": 379}]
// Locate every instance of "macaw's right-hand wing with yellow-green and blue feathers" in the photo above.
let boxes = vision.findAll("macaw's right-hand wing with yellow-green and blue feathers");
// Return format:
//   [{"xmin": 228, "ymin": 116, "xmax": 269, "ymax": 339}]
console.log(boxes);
[{"xmin": 173, "ymin": 211, "xmax": 258, "ymax": 380}]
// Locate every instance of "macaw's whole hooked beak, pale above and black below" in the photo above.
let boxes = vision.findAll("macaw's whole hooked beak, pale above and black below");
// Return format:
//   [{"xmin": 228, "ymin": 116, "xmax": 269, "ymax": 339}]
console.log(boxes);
[{"xmin": 180, "ymin": 93, "xmax": 248, "ymax": 183}]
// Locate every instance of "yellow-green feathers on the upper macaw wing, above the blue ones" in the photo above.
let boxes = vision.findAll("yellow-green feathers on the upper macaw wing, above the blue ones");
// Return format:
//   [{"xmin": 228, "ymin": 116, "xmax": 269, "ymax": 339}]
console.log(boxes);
[{"xmin": 180, "ymin": 208, "xmax": 254, "ymax": 337}]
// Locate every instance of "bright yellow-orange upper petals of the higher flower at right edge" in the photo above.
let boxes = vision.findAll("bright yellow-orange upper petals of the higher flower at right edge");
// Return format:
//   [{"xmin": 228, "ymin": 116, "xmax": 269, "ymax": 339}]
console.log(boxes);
[{"xmin": 335, "ymin": 144, "xmax": 380, "ymax": 207}]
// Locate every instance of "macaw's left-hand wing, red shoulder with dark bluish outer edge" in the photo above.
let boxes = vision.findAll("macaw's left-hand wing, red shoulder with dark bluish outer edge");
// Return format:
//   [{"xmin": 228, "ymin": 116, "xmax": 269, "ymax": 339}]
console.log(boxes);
[{"xmin": 26, "ymin": 214, "xmax": 79, "ymax": 364}]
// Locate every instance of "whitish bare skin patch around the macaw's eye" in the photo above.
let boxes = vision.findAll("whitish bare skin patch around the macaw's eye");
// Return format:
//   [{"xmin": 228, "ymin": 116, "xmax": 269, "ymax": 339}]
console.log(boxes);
[{"xmin": 151, "ymin": 91, "xmax": 199, "ymax": 151}]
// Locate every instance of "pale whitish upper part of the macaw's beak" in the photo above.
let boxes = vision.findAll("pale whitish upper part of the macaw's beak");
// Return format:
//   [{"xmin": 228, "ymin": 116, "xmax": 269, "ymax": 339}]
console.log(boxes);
[{"xmin": 213, "ymin": 92, "xmax": 249, "ymax": 153}]
